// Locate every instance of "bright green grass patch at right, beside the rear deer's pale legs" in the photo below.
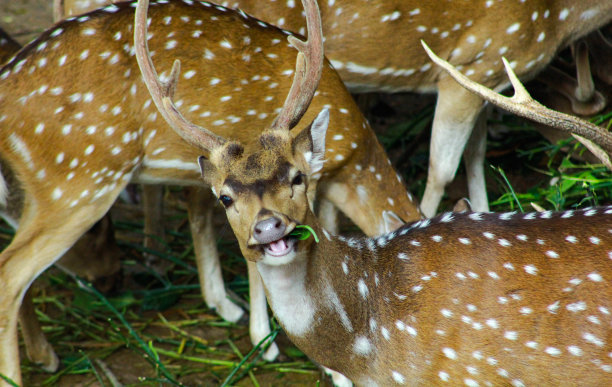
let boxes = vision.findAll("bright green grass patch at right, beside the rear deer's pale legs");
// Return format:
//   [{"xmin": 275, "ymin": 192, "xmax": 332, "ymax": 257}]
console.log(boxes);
[{"xmin": 379, "ymin": 96, "xmax": 612, "ymax": 211}]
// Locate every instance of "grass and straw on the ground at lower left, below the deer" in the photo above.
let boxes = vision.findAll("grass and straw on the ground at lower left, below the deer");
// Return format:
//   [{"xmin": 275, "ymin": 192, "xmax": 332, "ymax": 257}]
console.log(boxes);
[{"xmin": 14, "ymin": 214, "xmax": 319, "ymax": 386}]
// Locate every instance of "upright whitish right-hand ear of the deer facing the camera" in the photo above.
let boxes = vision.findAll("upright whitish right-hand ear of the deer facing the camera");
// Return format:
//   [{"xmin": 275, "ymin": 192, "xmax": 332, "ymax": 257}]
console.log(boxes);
[{"xmin": 293, "ymin": 109, "xmax": 329, "ymax": 175}]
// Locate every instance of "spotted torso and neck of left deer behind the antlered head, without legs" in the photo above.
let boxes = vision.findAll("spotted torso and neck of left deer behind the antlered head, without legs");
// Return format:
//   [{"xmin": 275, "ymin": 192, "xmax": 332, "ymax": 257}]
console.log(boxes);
[{"xmin": 0, "ymin": 2, "xmax": 418, "ymax": 233}]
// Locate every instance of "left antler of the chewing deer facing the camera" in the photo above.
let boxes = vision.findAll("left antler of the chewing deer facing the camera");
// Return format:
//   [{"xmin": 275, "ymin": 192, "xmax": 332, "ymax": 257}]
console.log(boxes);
[{"xmin": 134, "ymin": 0, "xmax": 225, "ymax": 152}]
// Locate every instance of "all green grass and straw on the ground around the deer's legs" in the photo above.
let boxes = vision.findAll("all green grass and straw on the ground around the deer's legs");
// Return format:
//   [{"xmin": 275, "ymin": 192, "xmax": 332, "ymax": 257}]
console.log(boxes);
[{"xmin": 5, "ymin": 94, "xmax": 612, "ymax": 386}]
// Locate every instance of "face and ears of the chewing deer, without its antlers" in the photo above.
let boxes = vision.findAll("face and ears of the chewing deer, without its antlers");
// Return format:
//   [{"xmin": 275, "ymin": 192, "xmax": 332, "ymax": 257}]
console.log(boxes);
[{"xmin": 200, "ymin": 110, "xmax": 329, "ymax": 265}]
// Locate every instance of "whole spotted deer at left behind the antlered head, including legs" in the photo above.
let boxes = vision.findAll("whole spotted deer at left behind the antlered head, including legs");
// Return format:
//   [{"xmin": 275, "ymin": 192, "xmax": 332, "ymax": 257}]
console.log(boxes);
[{"xmin": 0, "ymin": 1, "xmax": 420, "ymax": 382}]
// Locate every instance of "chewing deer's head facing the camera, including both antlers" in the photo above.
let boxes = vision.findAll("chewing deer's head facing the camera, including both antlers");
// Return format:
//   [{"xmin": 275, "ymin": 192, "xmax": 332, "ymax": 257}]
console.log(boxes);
[{"xmin": 134, "ymin": 0, "xmax": 329, "ymax": 264}]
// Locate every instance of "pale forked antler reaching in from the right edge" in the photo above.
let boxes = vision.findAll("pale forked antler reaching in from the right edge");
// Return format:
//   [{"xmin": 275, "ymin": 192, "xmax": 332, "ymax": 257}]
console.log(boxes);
[{"xmin": 421, "ymin": 41, "xmax": 612, "ymax": 170}]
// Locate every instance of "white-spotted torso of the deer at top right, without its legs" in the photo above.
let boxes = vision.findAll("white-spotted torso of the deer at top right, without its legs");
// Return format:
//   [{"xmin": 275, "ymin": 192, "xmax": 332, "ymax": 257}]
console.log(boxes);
[{"xmin": 223, "ymin": 0, "xmax": 612, "ymax": 91}]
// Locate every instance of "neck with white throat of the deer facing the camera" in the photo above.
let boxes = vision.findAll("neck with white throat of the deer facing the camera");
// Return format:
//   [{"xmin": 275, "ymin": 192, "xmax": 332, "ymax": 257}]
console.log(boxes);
[{"xmin": 257, "ymin": 211, "xmax": 378, "ymax": 375}]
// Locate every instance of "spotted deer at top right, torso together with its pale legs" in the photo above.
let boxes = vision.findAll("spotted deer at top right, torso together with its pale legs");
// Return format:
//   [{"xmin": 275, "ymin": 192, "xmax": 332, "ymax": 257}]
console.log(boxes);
[{"xmin": 222, "ymin": 0, "xmax": 612, "ymax": 216}]
